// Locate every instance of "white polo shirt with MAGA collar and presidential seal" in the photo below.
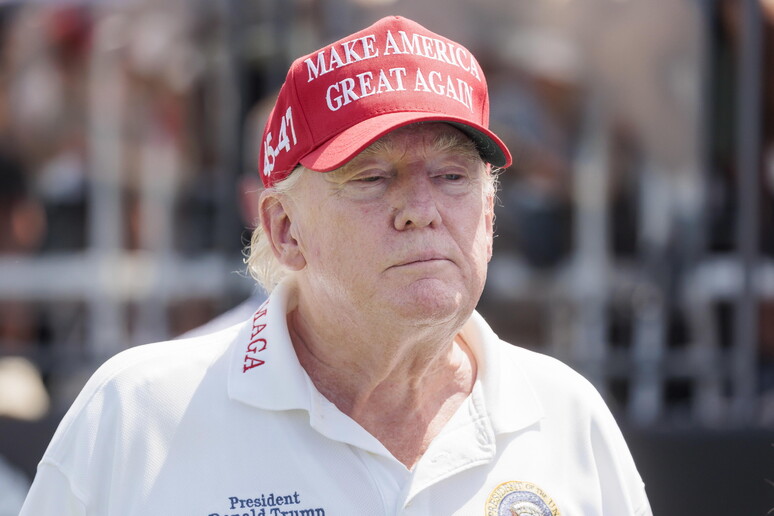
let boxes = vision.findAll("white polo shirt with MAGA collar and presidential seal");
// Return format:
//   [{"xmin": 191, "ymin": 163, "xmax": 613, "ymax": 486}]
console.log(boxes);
[{"xmin": 21, "ymin": 285, "xmax": 651, "ymax": 516}]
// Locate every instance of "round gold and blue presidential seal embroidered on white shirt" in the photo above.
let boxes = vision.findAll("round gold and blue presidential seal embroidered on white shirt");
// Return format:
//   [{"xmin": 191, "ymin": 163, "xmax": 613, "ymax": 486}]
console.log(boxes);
[{"xmin": 484, "ymin": 481, "xmax": 562, "ymax": 516}]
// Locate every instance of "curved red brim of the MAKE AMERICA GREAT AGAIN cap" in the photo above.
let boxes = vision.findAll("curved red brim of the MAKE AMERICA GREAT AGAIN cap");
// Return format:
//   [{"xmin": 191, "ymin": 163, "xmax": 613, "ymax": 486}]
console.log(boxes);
[{"xmin": 301, "ymin": 112, "xmax": 512, "ymax": 172}]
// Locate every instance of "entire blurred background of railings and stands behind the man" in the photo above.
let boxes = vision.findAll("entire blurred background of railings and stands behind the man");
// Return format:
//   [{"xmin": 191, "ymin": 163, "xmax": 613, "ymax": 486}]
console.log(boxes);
[{"xmin": 0, "ymin": 0, "xmax": 774, "ymax": 516}]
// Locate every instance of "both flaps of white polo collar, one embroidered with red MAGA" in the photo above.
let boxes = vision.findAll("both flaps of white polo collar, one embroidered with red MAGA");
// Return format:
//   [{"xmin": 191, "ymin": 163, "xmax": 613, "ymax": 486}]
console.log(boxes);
[{"xmin": 228, "ymin": 282, "xmax": 543, "ymax": 434}]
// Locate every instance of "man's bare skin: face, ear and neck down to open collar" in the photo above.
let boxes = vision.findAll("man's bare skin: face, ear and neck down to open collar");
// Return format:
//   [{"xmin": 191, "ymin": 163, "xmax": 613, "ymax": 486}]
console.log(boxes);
[{"xmin": 260, "ymin": 123, "xmax": 493, "ymax": 467}]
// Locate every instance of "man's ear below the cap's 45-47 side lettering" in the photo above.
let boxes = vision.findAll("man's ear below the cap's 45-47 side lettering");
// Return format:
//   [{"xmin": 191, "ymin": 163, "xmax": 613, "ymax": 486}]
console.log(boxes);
[{"xmin": 258, "ymin": 190, "xmax": 306, "ymax": 271}]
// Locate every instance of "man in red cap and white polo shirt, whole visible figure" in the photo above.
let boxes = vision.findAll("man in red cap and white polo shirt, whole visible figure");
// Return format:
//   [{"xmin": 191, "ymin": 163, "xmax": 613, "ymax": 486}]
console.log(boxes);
[{"xmin": 22, "ymin": 17, "xmax": 651, "ymax": 516}]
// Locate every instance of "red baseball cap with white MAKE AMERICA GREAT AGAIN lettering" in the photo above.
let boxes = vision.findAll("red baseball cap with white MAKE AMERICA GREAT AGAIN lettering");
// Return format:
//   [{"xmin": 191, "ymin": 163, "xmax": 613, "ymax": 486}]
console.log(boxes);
[{"xmin": 259, "ymin": 16, "xmax": 511, "ymax": 187}]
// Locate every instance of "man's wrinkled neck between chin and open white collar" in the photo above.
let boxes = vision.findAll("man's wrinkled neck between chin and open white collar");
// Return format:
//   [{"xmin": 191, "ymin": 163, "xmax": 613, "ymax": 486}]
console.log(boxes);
[{"xmin": 288, "ymin": 309, "xmax": 476, "ymax": 468}]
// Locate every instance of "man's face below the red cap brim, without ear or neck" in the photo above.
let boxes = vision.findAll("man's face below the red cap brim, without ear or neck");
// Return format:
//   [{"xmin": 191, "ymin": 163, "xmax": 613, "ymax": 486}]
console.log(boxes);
[{"xmin": 286, "ymin": 123, "xmax": 494, "ymax": 323}]
